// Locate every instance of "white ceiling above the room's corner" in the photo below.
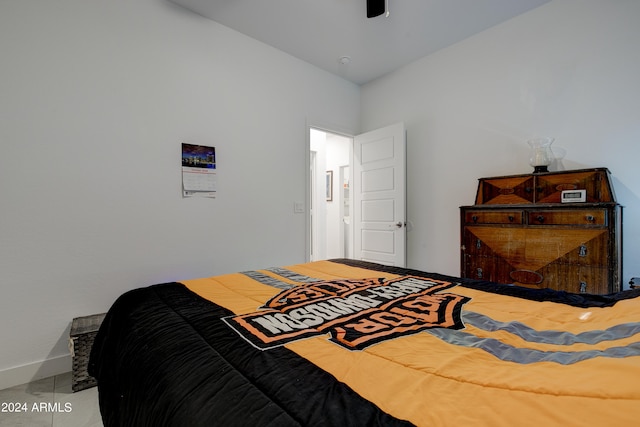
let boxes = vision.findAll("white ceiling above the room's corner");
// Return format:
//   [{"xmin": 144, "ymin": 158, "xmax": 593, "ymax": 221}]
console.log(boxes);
[{"xmin": 170, "ymin": 0, "xmax": 550, "ymax": 84}]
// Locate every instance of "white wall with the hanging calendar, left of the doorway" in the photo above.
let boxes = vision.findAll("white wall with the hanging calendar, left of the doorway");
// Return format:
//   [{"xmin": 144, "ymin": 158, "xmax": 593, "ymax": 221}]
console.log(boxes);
[{"xmin": 0, "ymin": 0, "xmax": 359, "ymax": 388}]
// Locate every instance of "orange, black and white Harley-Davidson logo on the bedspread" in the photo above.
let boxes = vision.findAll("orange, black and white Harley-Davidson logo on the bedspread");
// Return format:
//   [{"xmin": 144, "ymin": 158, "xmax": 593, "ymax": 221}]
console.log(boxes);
[{"xmin": 223, "ymin": 276, "xmax": 469, "ymax": 350}]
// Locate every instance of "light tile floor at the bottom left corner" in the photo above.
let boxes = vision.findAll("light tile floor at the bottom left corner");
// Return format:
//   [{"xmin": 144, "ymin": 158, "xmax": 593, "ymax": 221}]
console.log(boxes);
[{"xmin": 0, "ymin": 372, "xmax": 102, "ymax": 427}]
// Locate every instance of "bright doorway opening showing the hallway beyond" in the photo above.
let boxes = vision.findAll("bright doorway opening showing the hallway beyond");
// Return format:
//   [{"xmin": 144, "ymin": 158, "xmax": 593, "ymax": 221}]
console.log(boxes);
[{"xmin": 308, "ymin": 128, "xmax": 353, "ymax": 261}]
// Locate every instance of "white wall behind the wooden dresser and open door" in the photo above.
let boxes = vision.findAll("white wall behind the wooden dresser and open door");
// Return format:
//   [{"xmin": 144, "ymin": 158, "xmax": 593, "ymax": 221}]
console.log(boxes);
[{"xmin": 361, "ymin": 0, "xmax": 640, "ymax": 284}]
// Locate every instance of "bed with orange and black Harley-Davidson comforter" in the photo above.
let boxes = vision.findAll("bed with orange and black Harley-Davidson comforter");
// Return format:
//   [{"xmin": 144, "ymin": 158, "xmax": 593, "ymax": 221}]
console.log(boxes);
[{"xmin": 89, "ymin": 259, "xmax": 640, "ymax": 427}]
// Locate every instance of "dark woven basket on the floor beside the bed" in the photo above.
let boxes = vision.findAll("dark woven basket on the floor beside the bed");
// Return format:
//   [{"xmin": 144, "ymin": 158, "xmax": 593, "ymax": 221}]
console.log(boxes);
[{"xmin": 69, "ymin": 313, "xmax": 105, "ymax": 392}]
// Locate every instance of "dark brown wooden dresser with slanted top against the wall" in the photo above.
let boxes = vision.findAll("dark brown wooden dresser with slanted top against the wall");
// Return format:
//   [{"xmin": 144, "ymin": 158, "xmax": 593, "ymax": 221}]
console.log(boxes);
[{"xmin": 460, "ymin": 168, "xmax": 622, "ymax": 294}]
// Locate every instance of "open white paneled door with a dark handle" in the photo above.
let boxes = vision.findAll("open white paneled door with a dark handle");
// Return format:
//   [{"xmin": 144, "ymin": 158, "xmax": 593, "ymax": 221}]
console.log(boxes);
[{"xmin": 353, "ymin": 123, "xmax": 406, "ymax": 267}]
